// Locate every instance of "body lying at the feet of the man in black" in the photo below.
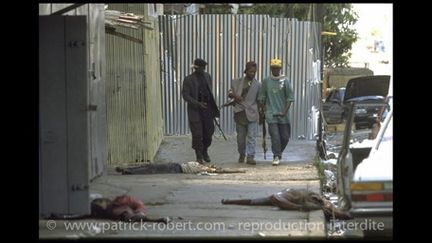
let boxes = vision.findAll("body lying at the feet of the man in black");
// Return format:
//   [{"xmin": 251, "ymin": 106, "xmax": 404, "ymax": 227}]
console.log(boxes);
[{"xmin": 116, "ymin": 161, "xmax": 246, "ymax": 175}]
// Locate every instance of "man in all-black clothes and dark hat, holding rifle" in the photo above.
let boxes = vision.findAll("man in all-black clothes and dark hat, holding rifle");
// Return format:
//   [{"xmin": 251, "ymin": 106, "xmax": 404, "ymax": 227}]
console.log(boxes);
[{"xmin": 182, "ymin": 59, "xmax": 220, "ymax": 164}]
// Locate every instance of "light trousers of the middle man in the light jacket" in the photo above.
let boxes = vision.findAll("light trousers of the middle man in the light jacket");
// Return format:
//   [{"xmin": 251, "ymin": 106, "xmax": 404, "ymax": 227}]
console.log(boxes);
[{"xmin": 236, "ymin": 122, "xmax": 258, "ymax": 156}]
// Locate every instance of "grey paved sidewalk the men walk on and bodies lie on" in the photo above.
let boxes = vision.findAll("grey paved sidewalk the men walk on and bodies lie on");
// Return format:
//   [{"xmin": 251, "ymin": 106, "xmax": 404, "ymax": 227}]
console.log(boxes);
[{"xmin": 39, "ymin": 136, "xmax": 325, "ymax": 239}]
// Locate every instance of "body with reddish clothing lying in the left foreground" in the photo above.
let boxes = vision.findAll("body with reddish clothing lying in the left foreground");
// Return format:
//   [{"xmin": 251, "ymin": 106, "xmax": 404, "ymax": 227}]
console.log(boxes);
[{"xmin": 49, "ymin": 195, "xmax": 168, "ymax": 223}]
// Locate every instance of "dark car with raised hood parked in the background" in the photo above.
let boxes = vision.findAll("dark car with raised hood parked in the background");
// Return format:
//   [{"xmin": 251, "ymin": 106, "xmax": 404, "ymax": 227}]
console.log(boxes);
[{"xmin": 323, "ymin": 75, "xmax": 390, "ymax": 129}]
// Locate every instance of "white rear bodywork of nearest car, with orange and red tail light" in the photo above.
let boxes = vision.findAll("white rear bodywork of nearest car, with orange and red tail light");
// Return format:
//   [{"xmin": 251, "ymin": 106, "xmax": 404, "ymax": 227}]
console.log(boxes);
[{"xmin": 350, "ymin": 109, "xmax": 393, "ymax": 235}]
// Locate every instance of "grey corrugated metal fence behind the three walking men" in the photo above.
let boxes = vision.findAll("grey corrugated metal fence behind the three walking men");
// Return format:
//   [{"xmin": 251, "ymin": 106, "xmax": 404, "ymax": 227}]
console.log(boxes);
[{"xmin": 159, "ymin": 15, "xmax": 321, "ymax": 139}]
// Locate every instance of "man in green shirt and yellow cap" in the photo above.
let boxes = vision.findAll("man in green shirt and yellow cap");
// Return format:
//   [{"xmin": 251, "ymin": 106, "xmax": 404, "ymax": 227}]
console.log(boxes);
[{"xmin": 258, "ymin": 59, "xmax": 294, "ymax": 165}]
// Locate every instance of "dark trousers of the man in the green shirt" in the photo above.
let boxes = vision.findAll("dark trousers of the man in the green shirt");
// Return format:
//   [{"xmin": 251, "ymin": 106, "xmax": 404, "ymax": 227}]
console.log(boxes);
[{"xmin": 268, "ymin": 123, "xmax": 291, "ymax": 158}]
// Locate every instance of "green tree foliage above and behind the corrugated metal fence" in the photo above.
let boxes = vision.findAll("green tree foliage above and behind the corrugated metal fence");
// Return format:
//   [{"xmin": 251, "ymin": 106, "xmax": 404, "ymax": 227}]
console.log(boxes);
[{"xmin": 202, "ymin": 3, "xmax": 358, "ymax": 67}]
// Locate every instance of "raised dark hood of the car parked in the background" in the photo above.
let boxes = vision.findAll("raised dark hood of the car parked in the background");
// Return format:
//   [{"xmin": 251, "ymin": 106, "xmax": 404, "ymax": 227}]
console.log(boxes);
[{"xmin": 344, "ymin": 75, "xmax": 390, "ymax": 103}]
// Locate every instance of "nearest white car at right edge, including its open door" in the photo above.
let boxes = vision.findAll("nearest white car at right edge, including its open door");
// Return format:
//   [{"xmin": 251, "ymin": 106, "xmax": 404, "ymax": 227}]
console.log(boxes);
[{"xmin": 337, "ymin": 99, "xmax": 393, "ymax": 236}]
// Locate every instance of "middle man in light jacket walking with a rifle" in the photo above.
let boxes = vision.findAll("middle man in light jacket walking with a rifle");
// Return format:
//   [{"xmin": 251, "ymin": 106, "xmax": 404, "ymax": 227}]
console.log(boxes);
[{"xmin": 228, "ymin": 61, "xmax": 261, "ymax": 165}]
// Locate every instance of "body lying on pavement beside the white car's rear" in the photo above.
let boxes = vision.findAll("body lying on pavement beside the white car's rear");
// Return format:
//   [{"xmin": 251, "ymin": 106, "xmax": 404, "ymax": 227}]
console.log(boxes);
[{"xmin": 221, "ymin": 189, "xmax": 352, "ymax": 219}]
